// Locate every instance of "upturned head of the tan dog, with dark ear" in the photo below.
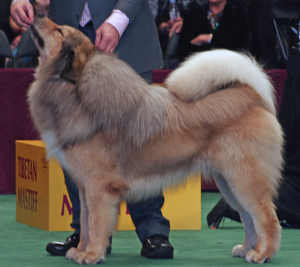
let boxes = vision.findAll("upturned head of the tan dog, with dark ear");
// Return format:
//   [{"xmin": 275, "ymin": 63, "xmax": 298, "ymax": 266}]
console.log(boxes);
[{"xmin": 31, "ymin": 14, "xmax": 95, "ymax": 82}]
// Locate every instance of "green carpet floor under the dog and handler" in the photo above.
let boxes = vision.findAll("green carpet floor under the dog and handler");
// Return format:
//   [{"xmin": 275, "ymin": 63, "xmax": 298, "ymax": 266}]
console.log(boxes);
[{"xmin": 0, "ymin": 193, "xmax": 300, "ymax": 267}]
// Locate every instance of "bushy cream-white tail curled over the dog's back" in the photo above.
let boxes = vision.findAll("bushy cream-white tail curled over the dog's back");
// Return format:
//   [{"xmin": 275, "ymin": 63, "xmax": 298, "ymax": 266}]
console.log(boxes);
[{"xmin": 166, "ymin": 49, "xmax": 276, "ymax": 114}]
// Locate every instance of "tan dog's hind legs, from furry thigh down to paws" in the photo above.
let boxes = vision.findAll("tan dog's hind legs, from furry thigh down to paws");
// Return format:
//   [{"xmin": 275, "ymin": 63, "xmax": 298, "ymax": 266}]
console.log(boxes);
[{"xmin": 208, "ymin": 107, "xmax": 283, "ymax": 263}]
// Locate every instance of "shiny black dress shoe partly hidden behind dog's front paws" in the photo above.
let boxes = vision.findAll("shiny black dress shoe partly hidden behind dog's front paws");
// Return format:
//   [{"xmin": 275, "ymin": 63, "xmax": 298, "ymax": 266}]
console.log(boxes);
[{"xmin": 46, "ymin": 234, "xmax": 112, "ymax": 256}]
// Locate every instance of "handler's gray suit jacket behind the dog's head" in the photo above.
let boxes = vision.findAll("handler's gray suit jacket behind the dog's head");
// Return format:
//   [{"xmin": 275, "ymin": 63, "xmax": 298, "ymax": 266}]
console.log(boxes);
[{"xmin": 44, "ymin": 0, "xmax": 162, "ymax": 73}]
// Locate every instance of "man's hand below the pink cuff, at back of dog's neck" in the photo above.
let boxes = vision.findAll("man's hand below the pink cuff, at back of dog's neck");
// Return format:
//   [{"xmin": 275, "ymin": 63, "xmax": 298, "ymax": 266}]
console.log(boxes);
[{"xmin": 95, "ymin": 22, "xmax": 120, "ymax": 54}]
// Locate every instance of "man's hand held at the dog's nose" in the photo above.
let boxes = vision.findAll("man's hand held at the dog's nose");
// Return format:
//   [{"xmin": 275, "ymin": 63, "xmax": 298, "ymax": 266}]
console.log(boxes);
[{"xmin": 10, "ymin": 0, "xmax": 34, "ymax": 28}]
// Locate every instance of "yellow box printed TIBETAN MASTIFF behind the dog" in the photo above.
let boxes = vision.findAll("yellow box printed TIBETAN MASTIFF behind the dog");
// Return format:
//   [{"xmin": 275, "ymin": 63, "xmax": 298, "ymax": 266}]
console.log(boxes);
[{"xmin": 16, "ymin": 141, "xmax": 201, "ymax": 231}]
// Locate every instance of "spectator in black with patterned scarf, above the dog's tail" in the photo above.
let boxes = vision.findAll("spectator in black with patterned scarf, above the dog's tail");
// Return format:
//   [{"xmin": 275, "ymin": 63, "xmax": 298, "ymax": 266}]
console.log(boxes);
[{"xmin": 178, "ymin": 0, "xmax": 250, "ymax": 61}]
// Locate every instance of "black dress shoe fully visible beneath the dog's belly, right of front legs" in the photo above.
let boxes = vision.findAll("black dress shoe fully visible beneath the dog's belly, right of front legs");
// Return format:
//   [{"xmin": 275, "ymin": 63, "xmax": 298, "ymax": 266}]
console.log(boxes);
[{"xmin": 141, "ymin": 235, "xmax": 174, "ymax": 259}]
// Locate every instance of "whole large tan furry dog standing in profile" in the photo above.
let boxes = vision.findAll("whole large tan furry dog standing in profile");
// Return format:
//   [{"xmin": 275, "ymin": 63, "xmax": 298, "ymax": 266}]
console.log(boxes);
[{"xmin": 28, "ymin": 17, "xmax": 283, "ymax": 264}]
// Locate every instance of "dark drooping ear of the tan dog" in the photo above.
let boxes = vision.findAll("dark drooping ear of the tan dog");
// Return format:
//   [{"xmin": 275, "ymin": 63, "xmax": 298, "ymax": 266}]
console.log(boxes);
[{"xmin": 60, "ymin": 50, "xmax": 84, "ymax": 83}]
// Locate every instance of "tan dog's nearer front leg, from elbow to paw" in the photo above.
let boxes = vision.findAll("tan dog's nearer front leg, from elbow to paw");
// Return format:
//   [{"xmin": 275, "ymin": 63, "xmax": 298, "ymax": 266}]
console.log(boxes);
[{"xmin": 70, "ymin": 177, "xmax": 126, "ymax": 264}]
